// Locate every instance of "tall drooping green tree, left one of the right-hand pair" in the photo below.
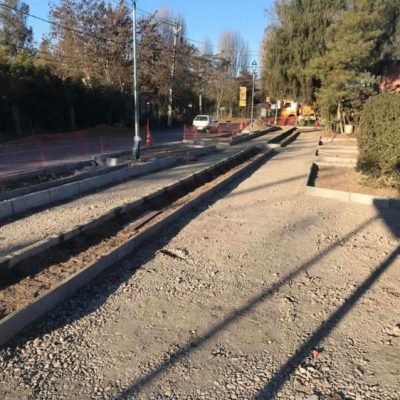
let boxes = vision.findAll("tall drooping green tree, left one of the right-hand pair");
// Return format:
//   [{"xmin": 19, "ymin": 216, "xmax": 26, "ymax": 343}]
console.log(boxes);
[{"xmin": 263, "ymin": 0, "xmax": 345, "ymax": 103}]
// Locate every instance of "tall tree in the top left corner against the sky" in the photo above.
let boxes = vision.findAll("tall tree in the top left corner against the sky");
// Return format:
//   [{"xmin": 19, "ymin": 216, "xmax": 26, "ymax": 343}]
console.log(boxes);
[{"xmin": 0, "ymin": 0, "xmax": 33, "ymax": 57}]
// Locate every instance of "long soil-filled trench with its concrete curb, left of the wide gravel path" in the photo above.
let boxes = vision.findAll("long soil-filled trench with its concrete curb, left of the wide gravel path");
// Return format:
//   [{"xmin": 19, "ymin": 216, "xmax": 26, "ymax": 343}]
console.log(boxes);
[{"xmin": 0, "ymin": 146, "xmax": 274, "ymax": 345}]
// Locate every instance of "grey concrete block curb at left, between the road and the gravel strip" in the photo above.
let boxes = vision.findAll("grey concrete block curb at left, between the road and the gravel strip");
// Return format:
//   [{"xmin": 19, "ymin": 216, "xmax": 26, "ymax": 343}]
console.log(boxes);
[{"xmin": 0, "ymin": 157, "xmax": 179, "ymax": 219}]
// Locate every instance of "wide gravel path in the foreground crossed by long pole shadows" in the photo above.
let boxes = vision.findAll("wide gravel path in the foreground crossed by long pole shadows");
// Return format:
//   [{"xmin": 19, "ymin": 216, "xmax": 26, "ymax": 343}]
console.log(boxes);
[{"xmin": 0, "ymin": 133, "xmax": 400, "ymax": 400}]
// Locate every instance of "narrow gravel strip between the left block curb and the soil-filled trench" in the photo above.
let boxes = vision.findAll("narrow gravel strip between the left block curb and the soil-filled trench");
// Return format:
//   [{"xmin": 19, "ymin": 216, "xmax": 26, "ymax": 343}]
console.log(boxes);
[{"xmin": 0, "ymin": 132, "xmax": 288, "ymax": 257}]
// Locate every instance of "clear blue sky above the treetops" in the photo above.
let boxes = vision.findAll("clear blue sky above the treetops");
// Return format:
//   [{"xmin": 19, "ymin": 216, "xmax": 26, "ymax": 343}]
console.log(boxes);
[{"xmin": 24, "ymin": 0, "xmax": 273, "ymax": 62}]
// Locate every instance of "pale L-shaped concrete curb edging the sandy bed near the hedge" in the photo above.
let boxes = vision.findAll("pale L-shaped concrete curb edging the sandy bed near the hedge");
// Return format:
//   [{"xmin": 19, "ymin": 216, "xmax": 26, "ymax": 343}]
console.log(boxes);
[{"xmin": 306, "ymin": 163, "xmax": 400, "ymax": 211}]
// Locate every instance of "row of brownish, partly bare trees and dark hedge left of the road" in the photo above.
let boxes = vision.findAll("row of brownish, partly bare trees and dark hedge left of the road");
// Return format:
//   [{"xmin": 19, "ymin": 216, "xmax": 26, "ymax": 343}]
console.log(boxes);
[{"xmin": 0, "ymin": 0, "xmax": 251, "ymax": 139}]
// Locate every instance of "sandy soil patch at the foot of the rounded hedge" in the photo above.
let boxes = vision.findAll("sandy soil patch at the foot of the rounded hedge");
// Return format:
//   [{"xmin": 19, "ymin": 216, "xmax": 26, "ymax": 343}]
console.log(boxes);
[{"xmin": 315, "ymin": 166, "xmax": 400, "ymax": 198}]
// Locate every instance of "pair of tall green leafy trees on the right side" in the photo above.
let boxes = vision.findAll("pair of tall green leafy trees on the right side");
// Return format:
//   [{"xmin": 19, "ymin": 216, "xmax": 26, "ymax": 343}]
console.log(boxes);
[{"xmin": 263, "ymin": 0, "xmax": 400, "ymax": 130}]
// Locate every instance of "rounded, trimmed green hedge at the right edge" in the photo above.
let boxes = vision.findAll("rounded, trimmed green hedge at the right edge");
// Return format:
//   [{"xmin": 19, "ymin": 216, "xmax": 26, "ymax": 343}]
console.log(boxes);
[{"xmin": 357, "ymin": 93, "xmax": 400, "ymax": 177}]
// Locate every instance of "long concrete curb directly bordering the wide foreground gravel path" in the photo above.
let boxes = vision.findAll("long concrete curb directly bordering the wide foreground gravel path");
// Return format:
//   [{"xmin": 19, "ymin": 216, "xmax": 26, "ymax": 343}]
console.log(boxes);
[{"xmin": 0, "ymin": 145, "xmax": 274, "ymax": 346}]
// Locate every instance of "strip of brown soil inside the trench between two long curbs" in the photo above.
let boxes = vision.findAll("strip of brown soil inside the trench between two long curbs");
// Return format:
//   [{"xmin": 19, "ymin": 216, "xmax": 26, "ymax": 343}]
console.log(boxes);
[{"xmin": 0, "ymin": 154, "xmax": 263, "ymax": 320}]
